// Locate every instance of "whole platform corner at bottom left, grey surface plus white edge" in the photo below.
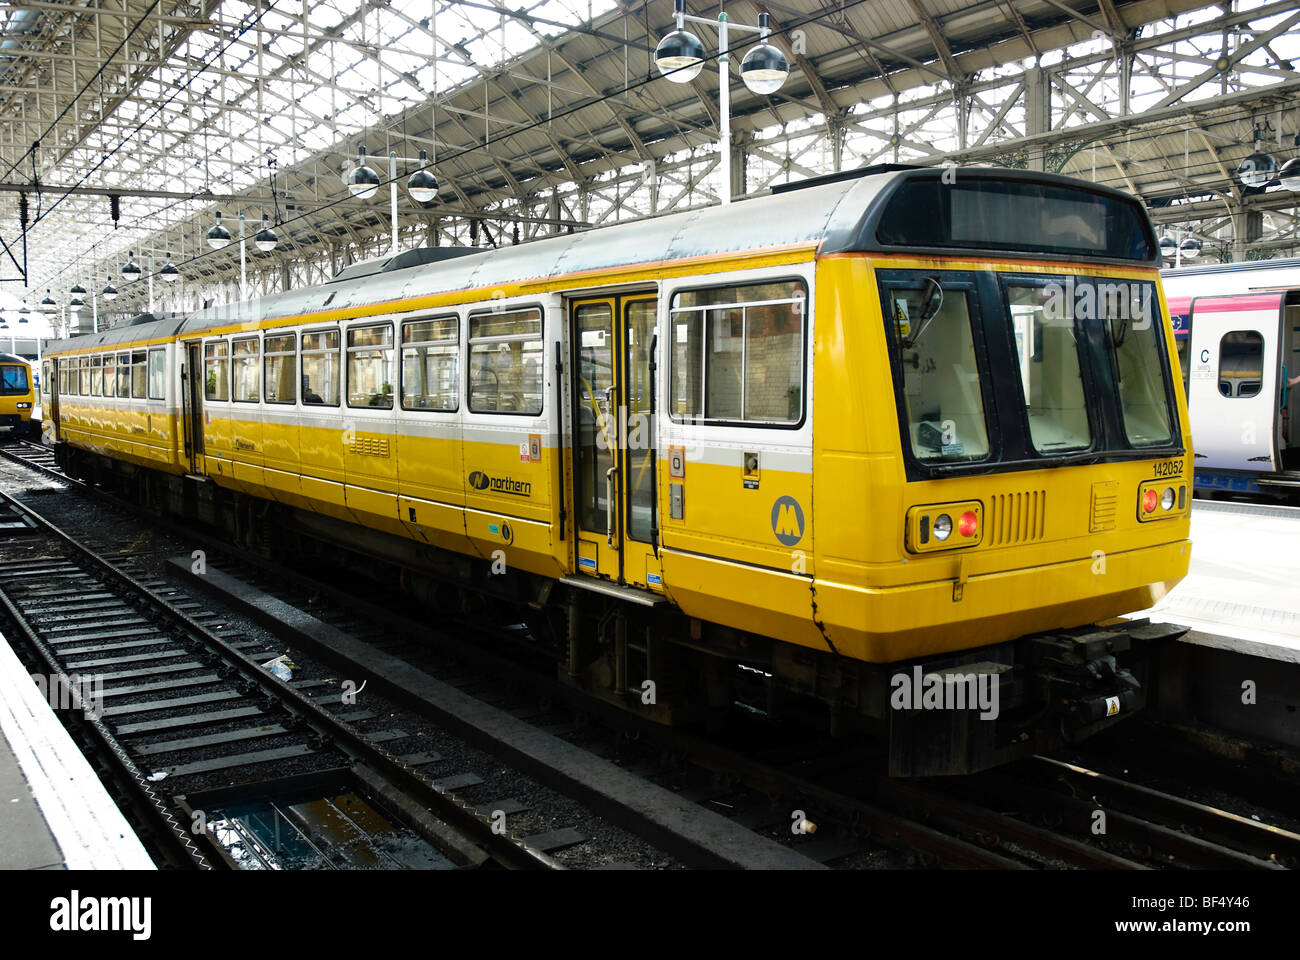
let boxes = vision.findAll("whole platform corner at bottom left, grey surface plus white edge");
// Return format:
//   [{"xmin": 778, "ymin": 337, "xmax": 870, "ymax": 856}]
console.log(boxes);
[{"xmin": 0, "ymin": 635, "xmax": 153, "ymax": 870}]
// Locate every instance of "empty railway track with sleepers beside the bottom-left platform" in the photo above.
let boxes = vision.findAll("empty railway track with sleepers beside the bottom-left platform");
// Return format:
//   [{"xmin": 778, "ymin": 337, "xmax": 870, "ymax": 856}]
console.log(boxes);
[{"xmin": 0, "ymin": 478, "xmax": 558, "ymax": 869}]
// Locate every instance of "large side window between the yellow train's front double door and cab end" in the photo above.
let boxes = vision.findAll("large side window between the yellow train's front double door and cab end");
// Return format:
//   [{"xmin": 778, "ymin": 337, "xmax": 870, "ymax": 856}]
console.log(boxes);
[{"xmin": 671, "ymin": 280, "xmax": 807, "ymax": 424}]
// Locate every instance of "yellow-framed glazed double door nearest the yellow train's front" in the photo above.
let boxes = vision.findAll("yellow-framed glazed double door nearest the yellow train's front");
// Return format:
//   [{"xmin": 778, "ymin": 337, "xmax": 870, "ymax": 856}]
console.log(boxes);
[{"xmin": 569, "ymin": 295, "xmax": 659, "ymax": 587}]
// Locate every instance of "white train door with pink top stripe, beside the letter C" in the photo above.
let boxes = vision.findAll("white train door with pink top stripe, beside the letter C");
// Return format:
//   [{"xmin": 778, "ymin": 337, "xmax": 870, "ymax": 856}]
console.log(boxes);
[{"xmin": 1187, "ymin": 293, "xmax": 1286, "ymax": 473}]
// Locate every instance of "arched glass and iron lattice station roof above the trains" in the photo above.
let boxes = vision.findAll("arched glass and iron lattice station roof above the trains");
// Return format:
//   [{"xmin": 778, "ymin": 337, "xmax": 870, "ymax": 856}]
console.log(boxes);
[{"xmin": 0, "ymin": 0, "xmax": 1300, "ymax": 325}]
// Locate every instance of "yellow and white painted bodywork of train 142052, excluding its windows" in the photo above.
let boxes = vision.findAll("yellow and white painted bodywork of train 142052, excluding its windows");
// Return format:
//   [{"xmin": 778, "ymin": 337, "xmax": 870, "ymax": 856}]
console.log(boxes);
[{"xmin": 47, "ymin": 170, "xmax": 1192, "ymax": 770}]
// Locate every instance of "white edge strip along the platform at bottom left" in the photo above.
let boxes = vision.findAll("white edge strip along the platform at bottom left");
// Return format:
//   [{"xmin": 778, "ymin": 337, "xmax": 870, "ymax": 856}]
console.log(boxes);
[{"xmin": 0, "ymin": 633, "xmax": 155, "ymax": 870}]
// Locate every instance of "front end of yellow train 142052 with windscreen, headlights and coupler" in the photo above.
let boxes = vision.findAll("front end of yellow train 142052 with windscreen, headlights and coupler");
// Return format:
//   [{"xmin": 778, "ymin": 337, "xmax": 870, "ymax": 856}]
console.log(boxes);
[{"xmin": 813, "ymin": 177, "xmax": 1191, "ymax": 775}]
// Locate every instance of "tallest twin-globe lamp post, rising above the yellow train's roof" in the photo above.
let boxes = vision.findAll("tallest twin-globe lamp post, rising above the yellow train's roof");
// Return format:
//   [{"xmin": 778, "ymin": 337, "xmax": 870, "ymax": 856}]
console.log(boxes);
[{"xmin": 654, "ymin": 0, "xmax": 790, "ymax": 204}]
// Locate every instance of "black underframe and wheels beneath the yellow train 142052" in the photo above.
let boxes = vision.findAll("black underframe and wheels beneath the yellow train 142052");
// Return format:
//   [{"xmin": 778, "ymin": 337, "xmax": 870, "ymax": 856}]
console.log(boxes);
[{"xmin": 56, "ymin": 444, "xmax": 1186, "ymax": 777}]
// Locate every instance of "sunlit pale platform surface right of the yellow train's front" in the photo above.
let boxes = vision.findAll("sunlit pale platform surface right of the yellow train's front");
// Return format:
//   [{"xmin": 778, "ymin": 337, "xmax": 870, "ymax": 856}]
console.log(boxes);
[{"xmin": 1131, "ymin": 500, "xmax": 1300, "ymax": 663}]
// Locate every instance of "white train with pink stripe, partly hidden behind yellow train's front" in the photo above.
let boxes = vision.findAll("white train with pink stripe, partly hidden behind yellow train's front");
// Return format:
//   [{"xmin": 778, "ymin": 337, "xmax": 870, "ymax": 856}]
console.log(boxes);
[{"xmin": 1164, "ymin": 259, "xmax": 1300, "ymax": 500}]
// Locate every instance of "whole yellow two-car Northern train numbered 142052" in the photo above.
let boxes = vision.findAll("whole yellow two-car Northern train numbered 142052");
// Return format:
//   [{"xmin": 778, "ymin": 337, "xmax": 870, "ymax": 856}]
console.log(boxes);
[{"xmin": 46, "ymin": 168, "xmax": 1192, "ymax": 774}]
